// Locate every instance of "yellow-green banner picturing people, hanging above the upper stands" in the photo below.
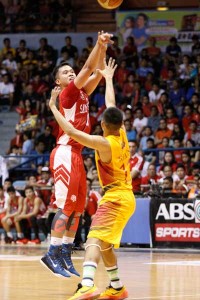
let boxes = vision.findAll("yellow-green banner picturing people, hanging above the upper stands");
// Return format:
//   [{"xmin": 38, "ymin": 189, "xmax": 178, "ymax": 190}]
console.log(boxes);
[{"xmin": 116, "ymin": 10, "xmax": 200, "ymax": 51}]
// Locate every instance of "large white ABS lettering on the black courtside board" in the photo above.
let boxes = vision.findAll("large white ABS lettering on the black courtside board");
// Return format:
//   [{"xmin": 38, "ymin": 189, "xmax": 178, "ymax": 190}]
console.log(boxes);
[{"xmin": 156, "ymin": 200, "xmax": 200, "ymax": 223}]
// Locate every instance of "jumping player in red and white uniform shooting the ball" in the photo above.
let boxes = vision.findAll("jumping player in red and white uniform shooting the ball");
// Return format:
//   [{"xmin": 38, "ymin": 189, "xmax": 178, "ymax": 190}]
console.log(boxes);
[{"xmin": 41, "ymin": 32, "xmax": 112, "ymax": 277}]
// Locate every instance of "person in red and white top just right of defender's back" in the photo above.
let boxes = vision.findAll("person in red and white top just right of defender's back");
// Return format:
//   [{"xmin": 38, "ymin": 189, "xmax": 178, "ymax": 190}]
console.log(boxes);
[{"xmin": 129, "ymin": 140, "xmax": 144, "ymax": 192}]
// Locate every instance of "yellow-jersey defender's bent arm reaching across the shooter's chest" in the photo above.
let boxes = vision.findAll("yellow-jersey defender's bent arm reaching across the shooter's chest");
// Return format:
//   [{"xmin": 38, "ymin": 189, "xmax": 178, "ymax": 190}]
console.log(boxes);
[{"xmin": 49, "ymin": 87, "xmax": 110, "ymax": 152}]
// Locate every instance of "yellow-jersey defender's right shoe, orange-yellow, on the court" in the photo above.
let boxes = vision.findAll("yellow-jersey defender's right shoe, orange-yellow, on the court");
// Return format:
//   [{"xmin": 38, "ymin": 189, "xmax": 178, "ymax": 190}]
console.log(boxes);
[{"xmin": 98, "ymin": 286, "xmax": 128, "ymax": 300}]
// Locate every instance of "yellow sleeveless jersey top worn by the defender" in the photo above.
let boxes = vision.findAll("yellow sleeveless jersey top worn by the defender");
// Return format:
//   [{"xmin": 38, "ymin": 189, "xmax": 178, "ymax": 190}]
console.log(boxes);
[{"xmin": 95, "ymin": 129, "xmax": 132, "ymax": 190}]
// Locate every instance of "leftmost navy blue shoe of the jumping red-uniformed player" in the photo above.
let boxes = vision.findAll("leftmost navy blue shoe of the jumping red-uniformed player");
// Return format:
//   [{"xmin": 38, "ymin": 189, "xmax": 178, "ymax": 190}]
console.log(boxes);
[{"xmin": 40, "ymin": 245, "xmax": 71, "ymax": 278}]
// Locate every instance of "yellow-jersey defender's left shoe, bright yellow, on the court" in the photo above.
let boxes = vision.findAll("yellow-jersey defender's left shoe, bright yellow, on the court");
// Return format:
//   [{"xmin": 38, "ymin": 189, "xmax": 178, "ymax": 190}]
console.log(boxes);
[{"xmin": 68, "ymin": 283, "xmax": 100, "ymax": 300}]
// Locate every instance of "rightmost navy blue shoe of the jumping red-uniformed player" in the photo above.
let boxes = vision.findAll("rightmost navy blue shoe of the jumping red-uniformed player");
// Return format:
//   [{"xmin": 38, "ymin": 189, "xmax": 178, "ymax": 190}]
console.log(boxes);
[{"xmin": 61, "ymin": 244, "xmax": 80, "ymax": 277}]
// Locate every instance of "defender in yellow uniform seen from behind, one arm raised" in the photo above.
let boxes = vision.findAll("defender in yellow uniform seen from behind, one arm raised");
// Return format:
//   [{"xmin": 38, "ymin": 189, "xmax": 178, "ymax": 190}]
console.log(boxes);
[{"xmin": 49, "ymin": 58, "xmax": 135, "ymax": 300}]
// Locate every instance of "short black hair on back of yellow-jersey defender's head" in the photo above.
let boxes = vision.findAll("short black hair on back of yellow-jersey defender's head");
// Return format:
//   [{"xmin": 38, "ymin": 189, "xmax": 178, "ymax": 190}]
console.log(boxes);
[{"xmin": 103, "ymin": 107, "xmax": 123, "ymax": 130}]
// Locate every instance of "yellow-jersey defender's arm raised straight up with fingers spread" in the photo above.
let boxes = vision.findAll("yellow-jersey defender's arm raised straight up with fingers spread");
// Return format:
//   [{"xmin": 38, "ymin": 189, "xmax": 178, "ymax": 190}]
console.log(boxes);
[{"xmin": 98, "ymin": 58, "xmax": 117, "ymax": 108}]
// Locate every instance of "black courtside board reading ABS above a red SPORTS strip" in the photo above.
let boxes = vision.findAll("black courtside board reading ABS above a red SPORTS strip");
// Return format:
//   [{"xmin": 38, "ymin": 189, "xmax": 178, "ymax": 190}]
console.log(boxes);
[{"xmin": 150, "ymin": 199, "xmax": 200, "ymax": 248}]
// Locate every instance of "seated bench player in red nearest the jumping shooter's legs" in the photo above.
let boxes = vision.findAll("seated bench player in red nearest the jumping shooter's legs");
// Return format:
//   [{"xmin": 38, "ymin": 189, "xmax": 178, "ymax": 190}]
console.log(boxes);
[{"xmin": 14, "ymin": 186, "xmax": 46, "ymax": 244}]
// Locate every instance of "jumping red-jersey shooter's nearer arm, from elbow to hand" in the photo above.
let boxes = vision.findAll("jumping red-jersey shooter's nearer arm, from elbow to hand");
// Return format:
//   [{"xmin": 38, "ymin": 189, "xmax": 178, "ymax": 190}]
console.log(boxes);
[{"xmin": 74, "ymin": 32, "xmax": 112, "ymax": 89}]
